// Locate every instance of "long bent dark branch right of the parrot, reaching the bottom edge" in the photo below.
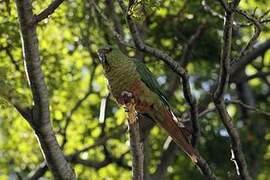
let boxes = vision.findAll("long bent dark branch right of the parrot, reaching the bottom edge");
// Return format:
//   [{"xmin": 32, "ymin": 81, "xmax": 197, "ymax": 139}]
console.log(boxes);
[{"xmin": 213, "ymin": 1, "xmax": 251, "ymax": 180}]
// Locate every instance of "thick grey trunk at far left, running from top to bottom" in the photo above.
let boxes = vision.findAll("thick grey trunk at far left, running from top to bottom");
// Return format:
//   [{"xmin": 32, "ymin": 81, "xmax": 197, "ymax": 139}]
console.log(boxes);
[{"xmin": 16, "ymin": 0, "xmax": 75, "ymax": 179}]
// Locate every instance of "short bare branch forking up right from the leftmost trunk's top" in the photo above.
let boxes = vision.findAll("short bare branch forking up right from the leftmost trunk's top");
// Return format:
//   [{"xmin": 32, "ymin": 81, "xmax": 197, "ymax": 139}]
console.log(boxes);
[{"xmin": 35, "ymin": 0, "xmax": 64, "ymax": 23}]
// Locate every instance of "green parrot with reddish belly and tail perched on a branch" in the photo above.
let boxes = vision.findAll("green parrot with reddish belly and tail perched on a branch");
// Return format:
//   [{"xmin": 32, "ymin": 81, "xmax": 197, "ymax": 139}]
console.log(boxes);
[{"xmin": 98, "ymin": 46, "xmax": 199, "ymax": 163}]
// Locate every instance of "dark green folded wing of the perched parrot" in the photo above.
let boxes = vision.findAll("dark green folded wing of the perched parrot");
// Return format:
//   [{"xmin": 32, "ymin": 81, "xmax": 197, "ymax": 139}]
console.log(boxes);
[{"xmin": 133, "ymin": 59, "xmax": 170, "ymax": 107}]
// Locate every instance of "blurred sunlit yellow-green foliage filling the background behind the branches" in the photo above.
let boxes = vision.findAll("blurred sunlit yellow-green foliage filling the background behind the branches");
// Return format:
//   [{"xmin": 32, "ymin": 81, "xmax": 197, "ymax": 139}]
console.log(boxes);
[{"xmin": 0, "ymin": 0, "xmax": 270, "ymax": 180}]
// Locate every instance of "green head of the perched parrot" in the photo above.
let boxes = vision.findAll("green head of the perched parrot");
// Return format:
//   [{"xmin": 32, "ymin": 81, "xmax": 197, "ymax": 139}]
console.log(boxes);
[{"xmin": 98, "ymin": 45, "xmax": 126, "ymax": 71}]
